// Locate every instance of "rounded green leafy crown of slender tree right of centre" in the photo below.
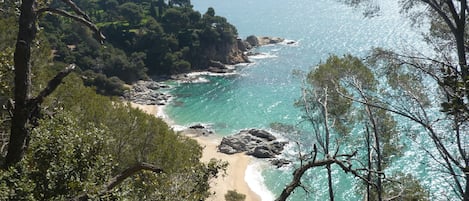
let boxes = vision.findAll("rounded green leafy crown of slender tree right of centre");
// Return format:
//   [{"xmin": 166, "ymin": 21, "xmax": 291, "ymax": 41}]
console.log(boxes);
[{"xmin": 307, "ymin": 55, "xmax": 377, "ymax": 134}]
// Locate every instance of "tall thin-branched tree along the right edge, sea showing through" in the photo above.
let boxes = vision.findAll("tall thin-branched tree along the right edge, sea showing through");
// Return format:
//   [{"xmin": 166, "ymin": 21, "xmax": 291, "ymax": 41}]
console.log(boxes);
[{"xmin": 334, "ymin": 0, "xmax": 469, "ymax": 201}]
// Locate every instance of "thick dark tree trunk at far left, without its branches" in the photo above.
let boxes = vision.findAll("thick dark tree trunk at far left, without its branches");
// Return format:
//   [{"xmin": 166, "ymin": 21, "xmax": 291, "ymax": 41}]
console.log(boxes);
[{"xmin": 4, "ymin": 0, "xmax": 36, "ymax": 167}]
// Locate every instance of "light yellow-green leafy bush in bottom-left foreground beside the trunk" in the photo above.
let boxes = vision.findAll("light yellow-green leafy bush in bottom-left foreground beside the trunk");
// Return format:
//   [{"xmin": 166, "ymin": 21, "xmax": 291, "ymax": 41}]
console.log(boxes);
[{"xmin": 26, "ymin": 113, "xmax": 115, "ymax": 200}]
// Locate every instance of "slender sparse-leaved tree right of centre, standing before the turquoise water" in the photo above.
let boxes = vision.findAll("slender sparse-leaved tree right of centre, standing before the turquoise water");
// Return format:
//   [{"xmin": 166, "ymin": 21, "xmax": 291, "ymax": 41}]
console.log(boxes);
[{"xmin": 277, "ymin": 55, "xmax": 424, "ymax": 200}]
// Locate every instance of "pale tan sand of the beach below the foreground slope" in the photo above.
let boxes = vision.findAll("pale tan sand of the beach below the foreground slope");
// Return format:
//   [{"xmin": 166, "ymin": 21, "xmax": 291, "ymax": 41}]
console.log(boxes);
[{"xmin": 131, "ymin": 103, "xmax": 261, "ymax": 201}]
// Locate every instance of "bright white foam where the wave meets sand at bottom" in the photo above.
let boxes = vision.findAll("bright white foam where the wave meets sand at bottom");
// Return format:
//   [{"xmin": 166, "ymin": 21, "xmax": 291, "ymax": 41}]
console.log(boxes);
[{"xmin": 244, "ymin": 161, "xmax": 275, "ymax": 201}]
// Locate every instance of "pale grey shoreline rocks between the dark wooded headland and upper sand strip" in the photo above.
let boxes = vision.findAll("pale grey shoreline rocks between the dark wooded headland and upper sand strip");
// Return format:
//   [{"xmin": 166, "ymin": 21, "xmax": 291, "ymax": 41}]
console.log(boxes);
[{"xmin": 124, "ymin": 81, "xmax": 171, "ymax": 105}]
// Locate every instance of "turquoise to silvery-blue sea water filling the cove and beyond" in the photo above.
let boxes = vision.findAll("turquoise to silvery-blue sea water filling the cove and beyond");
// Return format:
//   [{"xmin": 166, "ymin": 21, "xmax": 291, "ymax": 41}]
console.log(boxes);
[{"xmin": 165, "ymin": 0, "xmax": 449, "ymax": 201}]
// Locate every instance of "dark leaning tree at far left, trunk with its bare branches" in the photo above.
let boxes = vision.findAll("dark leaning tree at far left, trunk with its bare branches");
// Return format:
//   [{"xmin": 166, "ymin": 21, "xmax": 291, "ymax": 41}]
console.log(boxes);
[{"xmin": 3, "ymin": 0, "xmax": 104, "ymax": 168}]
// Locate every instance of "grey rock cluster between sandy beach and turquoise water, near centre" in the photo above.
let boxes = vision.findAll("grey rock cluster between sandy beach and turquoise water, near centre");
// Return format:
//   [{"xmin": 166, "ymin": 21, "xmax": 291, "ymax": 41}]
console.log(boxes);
[{"xmin": 218, "ymin": 129, "xmax": 287, "ymax": 158}]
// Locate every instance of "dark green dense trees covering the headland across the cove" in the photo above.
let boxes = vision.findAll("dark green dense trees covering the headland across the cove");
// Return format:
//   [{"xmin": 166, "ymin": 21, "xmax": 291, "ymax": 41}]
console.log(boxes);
[{"xmin": 41, "ymin": 0, "xmax": 237, "ymax": 95}]
